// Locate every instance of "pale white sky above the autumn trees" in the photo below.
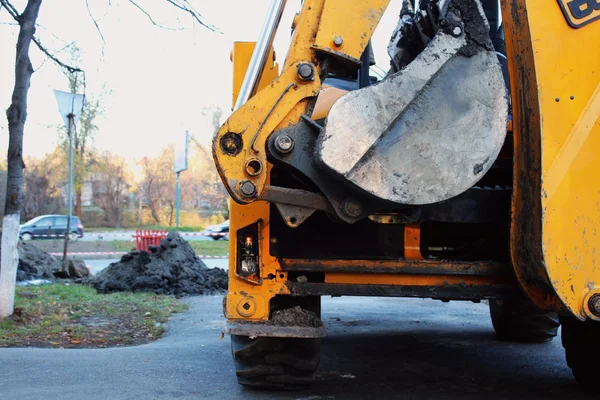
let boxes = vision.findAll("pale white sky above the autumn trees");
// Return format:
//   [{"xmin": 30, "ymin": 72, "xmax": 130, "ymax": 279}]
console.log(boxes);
[{"xmin": 0, "ymin": 0, "xmax": 401, "ymax": 160}]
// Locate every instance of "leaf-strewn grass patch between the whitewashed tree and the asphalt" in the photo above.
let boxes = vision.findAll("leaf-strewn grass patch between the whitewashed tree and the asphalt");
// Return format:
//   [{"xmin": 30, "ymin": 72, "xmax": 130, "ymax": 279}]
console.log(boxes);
[{"xmin": 0, "ymin": 283, "xmax": 187, "ymax": 347}]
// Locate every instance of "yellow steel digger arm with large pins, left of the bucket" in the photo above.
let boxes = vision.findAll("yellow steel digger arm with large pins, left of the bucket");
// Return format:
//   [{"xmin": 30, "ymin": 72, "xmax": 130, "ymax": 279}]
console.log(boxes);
[{"xmin": 213, "ymin": 0, "xmax": 388, "ymax": 204}]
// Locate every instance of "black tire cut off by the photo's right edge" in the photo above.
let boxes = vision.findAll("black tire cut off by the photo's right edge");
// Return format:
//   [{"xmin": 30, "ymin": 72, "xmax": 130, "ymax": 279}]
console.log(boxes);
[{"xmin": 561, "ymin": 317, "xmax": 600, "ymax": 393}]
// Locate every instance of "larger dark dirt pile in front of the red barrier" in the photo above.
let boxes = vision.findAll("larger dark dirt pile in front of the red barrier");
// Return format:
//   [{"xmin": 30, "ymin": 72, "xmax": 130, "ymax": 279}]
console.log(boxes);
[{"xmin": 89, "ymin": 232, "xmax": 227, "ymax": 296}]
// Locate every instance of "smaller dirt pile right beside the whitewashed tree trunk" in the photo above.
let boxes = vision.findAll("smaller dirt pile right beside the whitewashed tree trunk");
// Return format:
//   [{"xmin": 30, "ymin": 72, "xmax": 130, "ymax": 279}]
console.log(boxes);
[{"xmin": 17, "ymin": 242, "xmax": 60, "ymax": 281}]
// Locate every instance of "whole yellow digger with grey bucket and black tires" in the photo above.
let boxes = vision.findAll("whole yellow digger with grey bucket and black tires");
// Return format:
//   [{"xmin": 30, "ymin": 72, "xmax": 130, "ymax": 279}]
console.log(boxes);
[{"xmin": 213, "ymin": 0, "xmax": 600, "ymax": 390}]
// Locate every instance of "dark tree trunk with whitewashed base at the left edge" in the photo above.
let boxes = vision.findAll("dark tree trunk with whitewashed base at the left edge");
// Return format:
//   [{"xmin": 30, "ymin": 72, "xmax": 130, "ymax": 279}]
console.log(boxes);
[{"xmin": 0, "ymin": 0, "xmax": 42, "ymax": 318}]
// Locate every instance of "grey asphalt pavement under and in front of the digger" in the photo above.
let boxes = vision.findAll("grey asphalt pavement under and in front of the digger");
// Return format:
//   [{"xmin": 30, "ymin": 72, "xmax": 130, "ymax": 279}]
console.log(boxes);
[{"xmin": 0, "ymin": 296, "xmax": 596, "ymax": 400}]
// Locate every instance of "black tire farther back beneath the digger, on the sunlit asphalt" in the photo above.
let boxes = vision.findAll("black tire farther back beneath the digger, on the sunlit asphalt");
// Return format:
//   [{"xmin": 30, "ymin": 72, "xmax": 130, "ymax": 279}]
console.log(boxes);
[{"xmin": 490, "ymin": 299, "xmax": 560, "ymax": 343}]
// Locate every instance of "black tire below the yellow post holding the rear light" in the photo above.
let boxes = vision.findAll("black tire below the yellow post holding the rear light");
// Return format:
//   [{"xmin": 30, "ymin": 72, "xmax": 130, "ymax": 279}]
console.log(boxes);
[{"xmin": 231, "ymin": 335, "xmax": 321, "ymax": 390}]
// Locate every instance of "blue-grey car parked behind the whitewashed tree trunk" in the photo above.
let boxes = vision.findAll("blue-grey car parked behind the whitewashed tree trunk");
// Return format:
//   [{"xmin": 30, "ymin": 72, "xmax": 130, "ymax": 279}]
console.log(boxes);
[{"xmin": 19, "ymin": 215, "xmax": 83, "ymax": 240}]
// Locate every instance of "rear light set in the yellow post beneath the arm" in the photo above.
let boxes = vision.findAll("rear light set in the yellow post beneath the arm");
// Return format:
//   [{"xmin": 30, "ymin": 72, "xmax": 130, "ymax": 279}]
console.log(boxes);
[{"xmin": 235, "ymin": 221, "xmax": 261, "ymax": 283}]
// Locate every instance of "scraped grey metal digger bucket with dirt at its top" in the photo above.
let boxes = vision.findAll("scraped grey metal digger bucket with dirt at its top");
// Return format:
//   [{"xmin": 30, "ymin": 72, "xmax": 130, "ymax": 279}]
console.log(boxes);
[{"xmin": 317, "ymin": 1, "xmax": 508, "ymax": 205}]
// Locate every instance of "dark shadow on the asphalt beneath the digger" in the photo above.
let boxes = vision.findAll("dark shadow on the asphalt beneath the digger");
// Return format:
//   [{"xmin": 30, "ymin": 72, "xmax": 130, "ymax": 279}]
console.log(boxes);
[{"xmin": 241, "ymin": 323, "xmax": 597, "ymax": 400}]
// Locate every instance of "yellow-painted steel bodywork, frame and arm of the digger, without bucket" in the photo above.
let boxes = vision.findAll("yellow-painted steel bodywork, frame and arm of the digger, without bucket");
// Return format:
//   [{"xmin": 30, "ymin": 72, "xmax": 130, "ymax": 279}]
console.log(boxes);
[{"xmin": 220, "ymin": 0, "xmax": 600, "ymax": 321}]
